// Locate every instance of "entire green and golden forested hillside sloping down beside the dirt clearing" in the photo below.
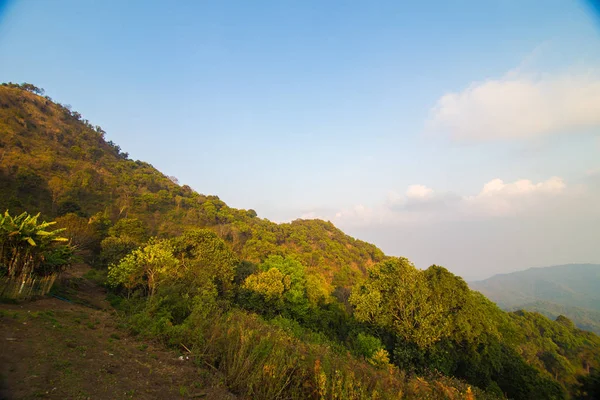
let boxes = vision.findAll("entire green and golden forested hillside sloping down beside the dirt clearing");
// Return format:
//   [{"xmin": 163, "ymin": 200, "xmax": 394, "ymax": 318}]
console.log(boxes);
[{"xmin": 0, "ymin": 84, "xmax": 600, "ymax": 399}]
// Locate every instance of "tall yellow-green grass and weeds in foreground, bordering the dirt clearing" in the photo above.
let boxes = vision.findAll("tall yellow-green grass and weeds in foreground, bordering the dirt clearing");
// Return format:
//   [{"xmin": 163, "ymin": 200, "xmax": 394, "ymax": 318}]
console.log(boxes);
[{"xmin": 143, "ymin": 311, "xmax": 485, "ymax": 399}]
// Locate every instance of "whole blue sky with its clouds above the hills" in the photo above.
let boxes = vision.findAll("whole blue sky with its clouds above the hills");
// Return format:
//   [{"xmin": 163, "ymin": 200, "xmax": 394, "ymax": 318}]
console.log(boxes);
[{"xmin": 0, "ymin": 0, "xmax": 600, "ymax": 280}]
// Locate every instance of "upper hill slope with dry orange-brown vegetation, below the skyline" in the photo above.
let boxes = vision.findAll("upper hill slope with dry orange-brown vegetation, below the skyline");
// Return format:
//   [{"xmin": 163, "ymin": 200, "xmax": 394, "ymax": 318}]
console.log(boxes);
[{"xmin": 0, "ymin": 85, "xmax": 383, "ymax": 287}]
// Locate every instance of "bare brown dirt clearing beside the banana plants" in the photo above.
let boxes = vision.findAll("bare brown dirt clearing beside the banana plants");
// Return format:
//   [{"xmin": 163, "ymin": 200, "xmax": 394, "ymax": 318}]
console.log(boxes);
[{"xmin": 0, "ymin": 266, "xmax": 235, "ymax": 400}]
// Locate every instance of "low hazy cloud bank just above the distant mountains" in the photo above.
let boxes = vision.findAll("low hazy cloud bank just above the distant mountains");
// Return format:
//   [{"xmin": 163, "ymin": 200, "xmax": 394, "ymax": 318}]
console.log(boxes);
[{"xmin": 330, "ymin": 177, "xmax": 600, "ymax": 279}]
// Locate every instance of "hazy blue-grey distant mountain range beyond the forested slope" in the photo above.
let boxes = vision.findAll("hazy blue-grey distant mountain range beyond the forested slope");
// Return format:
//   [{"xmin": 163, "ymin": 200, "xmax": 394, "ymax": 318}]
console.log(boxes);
[{"xmin": 469, "ymin": 264, "xmax": 600, "ymax": 333}]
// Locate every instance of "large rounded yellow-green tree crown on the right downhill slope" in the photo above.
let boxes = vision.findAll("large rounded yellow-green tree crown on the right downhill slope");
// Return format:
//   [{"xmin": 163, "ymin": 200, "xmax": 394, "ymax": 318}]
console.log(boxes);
[{"xmin": 350, "ymin": 258, "xmax": 497, "ymax": 348}]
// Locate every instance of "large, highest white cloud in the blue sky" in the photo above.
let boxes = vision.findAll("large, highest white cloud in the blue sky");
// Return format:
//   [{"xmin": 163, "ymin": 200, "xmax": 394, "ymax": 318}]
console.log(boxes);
[{"xmin": 427, "ymin": 72, "xmax": 600, "ymax": 140}]
